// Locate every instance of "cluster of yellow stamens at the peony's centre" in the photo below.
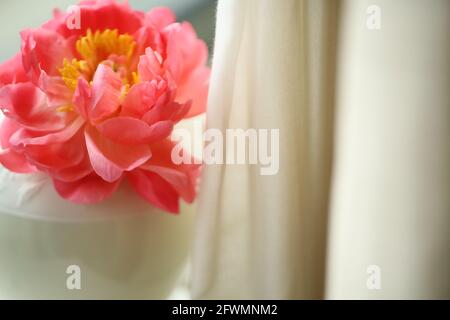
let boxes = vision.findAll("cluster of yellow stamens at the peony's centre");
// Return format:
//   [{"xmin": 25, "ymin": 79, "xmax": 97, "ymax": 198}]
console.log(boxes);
[{"xmin": 59, "ymin": 29, "xmax": 137, "ymax": 90}]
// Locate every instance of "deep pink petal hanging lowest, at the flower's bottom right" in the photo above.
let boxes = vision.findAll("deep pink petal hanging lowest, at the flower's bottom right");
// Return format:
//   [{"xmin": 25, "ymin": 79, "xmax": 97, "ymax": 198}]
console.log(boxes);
[{"xmin": 128, "ymin": 170, "xmax": 180, "ymax": 213}]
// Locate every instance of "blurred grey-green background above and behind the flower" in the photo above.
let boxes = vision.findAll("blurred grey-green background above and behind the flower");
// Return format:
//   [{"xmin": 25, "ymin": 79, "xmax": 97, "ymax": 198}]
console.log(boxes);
[{"xmin": 0, "ymin": 0, "xmax": 216, "ymax": 62}]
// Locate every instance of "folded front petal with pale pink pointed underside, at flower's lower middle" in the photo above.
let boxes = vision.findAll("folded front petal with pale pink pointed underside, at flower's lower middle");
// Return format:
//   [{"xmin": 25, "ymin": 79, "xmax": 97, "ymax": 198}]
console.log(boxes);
[{"xmin": 85, "ymin": 126, "xmax": 152, "ymax": 182}]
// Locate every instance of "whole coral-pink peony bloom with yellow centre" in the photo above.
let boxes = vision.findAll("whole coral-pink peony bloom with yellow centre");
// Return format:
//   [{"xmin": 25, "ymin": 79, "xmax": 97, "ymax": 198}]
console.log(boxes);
[{"xmin": 0, "ymin": 0, "xmax": 210, "ymax": 213}]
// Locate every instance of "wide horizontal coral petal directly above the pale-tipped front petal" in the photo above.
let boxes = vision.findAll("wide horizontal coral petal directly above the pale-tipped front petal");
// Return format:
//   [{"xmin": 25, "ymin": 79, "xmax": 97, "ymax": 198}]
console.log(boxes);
[{"xmin": 97, "ymin": 117, "xmax": 173, "ymax": 145}]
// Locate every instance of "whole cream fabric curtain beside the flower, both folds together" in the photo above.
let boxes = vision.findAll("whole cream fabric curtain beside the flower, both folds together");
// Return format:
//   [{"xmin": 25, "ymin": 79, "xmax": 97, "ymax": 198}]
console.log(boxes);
[{"xmin": 192, "ymin": 0, "xmax": 450, "ymax": 299}]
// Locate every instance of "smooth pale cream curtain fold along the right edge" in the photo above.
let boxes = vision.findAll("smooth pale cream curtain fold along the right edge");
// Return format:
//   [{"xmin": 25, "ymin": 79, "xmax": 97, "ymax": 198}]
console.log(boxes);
[{"xmin": 327, "ymin": 0, "xmax": 450, "ymax": 299}]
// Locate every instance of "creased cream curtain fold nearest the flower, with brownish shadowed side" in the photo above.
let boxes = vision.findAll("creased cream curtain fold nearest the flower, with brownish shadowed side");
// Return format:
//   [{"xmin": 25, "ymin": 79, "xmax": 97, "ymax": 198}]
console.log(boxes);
[{"xmin": 192, "ymin": 0, "xmax": 336, "ymax": 298}]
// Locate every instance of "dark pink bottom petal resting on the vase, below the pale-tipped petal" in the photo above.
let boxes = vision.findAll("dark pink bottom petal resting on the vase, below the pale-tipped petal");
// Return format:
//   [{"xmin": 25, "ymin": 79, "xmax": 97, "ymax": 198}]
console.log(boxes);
[{"xmin": 53, "ymin": 174, "xmax": 120, "ymax": 204}]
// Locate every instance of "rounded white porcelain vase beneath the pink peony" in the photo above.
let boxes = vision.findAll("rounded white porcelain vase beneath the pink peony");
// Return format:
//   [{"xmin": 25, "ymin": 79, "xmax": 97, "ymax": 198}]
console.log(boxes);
[{"xmin": 0, "ymin": 168, "xmax": 194, "ymax": 299}]
